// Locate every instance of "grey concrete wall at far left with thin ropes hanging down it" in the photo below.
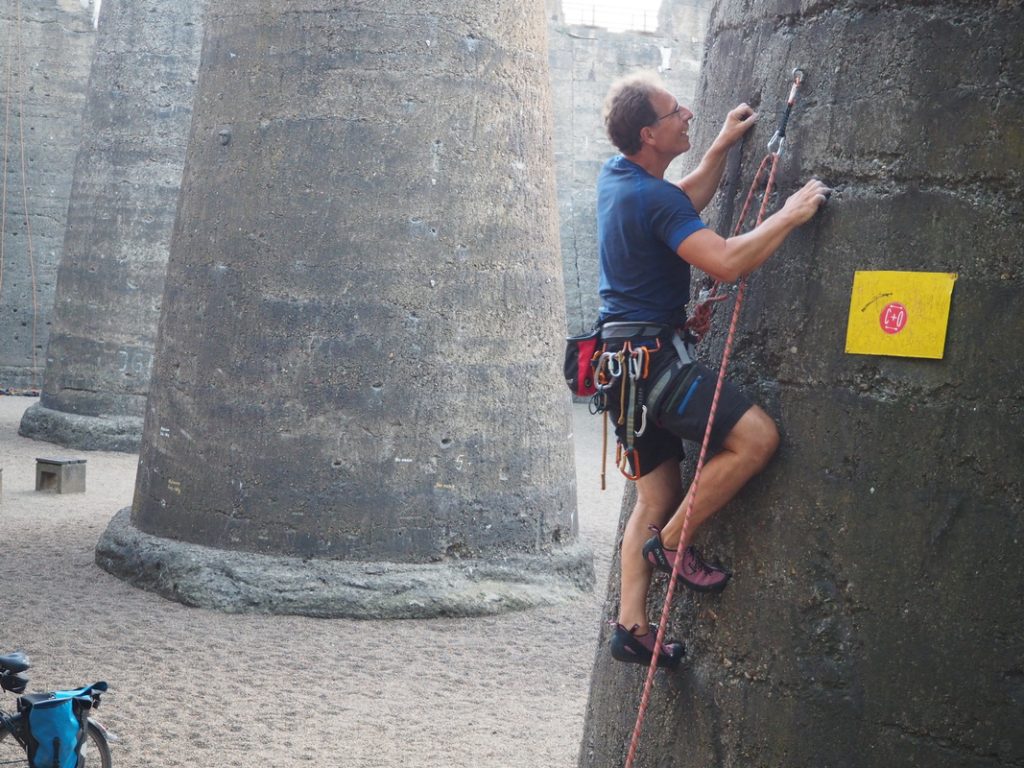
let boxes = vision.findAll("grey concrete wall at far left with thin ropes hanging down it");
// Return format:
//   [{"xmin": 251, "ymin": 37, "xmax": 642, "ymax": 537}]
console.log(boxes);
[{"xmin": 0, "ymin": 0, "xmax": 95, "ymax": 389}]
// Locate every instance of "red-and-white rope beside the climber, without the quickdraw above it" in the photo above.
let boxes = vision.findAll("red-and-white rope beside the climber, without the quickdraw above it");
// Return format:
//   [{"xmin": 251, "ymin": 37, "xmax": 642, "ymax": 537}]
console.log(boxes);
[{"xmin": 626, "ymin": 153, "xmax": 778, "ymax": 768}]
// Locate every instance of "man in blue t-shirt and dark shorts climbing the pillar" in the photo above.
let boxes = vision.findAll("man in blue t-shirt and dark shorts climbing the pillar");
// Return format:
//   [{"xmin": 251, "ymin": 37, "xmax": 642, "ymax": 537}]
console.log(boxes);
[{"xmin": 597, "ymin": 74, "xmax": 830, "ymax": 666}]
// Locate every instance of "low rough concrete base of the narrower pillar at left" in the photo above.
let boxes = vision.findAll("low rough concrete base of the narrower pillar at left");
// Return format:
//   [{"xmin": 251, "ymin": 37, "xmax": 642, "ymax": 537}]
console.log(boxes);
[{"xmin": 17, "ymin": 402, "xmax": 143, "ymax": 454}]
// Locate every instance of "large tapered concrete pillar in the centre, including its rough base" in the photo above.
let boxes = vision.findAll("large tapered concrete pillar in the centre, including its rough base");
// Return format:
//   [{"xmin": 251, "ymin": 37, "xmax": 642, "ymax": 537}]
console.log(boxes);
[{"xmin": 97, "ymin": 0, "xmax": 592, "ymax": 615}]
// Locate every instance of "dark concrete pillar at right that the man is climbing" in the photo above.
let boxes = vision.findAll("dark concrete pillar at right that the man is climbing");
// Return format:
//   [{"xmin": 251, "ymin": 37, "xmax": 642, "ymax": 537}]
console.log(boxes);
[{"xmin": 580, "ymin": 0, "xmax": 1024, "ymax": 768}]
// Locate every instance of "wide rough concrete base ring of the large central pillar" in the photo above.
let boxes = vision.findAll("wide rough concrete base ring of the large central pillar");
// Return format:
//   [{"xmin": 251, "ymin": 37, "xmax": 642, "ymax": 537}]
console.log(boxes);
[{"xmin": 96, "ymin": 508, "xmax": 594, "ymax": 618}]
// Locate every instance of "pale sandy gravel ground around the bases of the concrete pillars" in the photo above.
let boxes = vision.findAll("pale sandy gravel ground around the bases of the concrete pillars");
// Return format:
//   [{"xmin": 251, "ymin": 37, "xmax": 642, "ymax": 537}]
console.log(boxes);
[{"xmin": 0, "ymin": 396, "xmax": 623, "ymax": 768}]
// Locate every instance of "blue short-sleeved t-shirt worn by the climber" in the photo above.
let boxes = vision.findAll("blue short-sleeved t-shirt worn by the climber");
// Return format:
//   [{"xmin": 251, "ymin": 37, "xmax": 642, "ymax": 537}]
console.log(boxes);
[{"xmin": 597, "ymin": 155, "xmax": 705, "ymax": 325}]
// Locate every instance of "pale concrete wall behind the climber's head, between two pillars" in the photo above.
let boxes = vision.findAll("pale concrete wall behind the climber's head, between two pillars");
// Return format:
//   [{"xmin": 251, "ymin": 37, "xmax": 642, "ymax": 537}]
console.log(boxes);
[{"xmin": 548, "ymin": 0, "xmax": 712, "ymax": 333}]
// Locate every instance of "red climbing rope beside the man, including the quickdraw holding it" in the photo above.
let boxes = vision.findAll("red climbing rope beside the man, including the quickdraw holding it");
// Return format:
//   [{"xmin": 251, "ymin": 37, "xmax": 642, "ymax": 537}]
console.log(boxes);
[{"xmin": 626, "ymin": 69, "xmax": 804, "ymax": 768}]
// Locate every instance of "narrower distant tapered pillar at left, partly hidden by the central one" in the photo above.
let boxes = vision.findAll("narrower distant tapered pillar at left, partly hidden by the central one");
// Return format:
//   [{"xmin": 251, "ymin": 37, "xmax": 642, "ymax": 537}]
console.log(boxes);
[{"xmin": 18, "ymin": 0, "xmax": 206, "ymax": 451}]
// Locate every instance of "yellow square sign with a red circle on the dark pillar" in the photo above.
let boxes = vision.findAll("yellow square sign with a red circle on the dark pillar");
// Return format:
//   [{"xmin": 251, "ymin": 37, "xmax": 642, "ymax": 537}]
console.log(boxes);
[{"xmin": 846, "ymin": 272, "xmax": 956, "ymax": 359}]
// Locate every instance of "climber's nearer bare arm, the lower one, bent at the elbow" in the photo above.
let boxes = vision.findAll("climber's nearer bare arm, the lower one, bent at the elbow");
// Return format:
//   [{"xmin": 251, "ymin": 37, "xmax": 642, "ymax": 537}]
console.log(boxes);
[{"xmin": 676, "ymin": 179, "xmax": 831, "ymax": 283}]
